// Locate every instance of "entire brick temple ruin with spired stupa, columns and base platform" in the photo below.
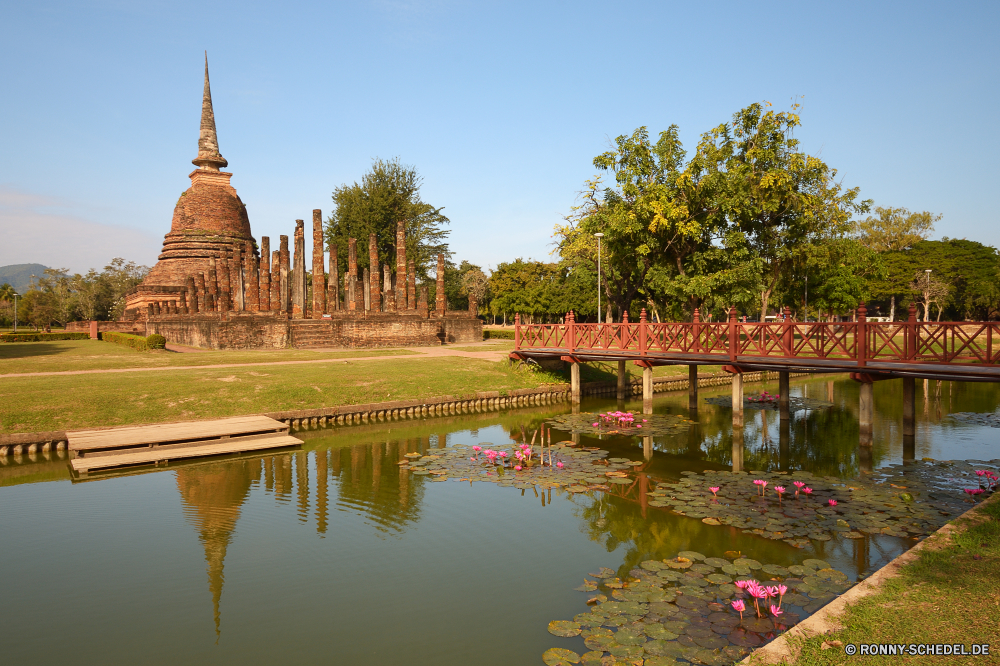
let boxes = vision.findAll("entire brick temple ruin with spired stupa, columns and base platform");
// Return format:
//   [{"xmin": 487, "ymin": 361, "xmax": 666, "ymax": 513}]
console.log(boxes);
[{"xmin": 119, "ymin": 58, "xmax": 482, "ymax": 349}]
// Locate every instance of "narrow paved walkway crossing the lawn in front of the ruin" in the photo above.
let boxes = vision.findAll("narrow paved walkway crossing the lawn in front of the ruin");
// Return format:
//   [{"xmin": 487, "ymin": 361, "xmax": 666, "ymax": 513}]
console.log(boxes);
[{"xmin": 0, "ymin": 342, "xmax": 510, "ymax": 379}]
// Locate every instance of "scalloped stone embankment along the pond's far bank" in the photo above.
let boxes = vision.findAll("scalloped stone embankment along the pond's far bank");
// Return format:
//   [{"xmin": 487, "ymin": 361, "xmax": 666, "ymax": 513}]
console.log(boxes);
[{"xmin": 0, "ymin": 372, "xmax": 807, "ymax": 456}]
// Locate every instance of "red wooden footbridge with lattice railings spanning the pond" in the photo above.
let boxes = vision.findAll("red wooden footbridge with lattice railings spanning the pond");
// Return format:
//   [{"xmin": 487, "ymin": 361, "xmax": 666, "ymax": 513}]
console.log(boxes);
[{"xmin": 511, "ymin": 305, "xmax": 1000, "ymax": 382}]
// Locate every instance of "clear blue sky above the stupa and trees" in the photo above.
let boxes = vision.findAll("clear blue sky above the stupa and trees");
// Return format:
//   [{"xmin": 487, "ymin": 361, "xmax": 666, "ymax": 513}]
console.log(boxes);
[{"xmin": 0, "ymin": 0, "xmax": 1000, "ymax": 271}]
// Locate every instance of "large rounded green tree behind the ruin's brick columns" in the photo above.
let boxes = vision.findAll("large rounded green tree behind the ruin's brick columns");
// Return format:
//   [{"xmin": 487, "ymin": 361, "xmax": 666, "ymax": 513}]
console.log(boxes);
[{"xmin": 326, "ymin": 158, "xmax": 451, "ymax": 282}]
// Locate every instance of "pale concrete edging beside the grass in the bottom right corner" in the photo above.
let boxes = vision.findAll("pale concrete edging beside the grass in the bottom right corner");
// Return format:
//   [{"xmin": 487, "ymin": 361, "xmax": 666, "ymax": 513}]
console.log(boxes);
[{"xmin": 739, "ymin": 492, "xmax": 986, "ymax": 666}]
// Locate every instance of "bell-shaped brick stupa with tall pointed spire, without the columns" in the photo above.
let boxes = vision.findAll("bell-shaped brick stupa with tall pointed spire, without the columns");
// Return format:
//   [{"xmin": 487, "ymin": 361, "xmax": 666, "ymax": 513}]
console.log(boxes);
[{"xmin": 125, "ymin": 54, "xmax": 257, "ymax": 319}]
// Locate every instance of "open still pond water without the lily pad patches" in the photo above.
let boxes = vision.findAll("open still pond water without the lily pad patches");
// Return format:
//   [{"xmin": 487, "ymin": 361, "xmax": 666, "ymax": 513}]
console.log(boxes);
[{"xmin": 0, "ymin": 376, "xmax": 1000, "ymax": 664}]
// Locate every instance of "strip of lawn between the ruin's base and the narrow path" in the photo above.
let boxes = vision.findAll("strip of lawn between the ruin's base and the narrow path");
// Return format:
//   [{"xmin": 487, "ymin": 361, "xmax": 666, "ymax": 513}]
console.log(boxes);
[{"xmin": 0, "ymin": 340, "xmax": 414, "ymax": 374}]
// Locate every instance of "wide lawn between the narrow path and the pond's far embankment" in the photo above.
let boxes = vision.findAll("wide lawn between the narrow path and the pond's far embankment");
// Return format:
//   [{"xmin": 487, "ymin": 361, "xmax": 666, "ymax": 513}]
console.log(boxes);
[{"xmin": 0, "ymin": 354, "xmax": 565, "ymax": 433}]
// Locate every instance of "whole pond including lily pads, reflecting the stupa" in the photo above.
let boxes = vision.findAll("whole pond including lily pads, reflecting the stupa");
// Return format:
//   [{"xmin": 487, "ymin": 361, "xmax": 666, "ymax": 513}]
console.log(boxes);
[{"xmin": 0, "ymin": 376, "xmax": 1000, "ymax": 665}]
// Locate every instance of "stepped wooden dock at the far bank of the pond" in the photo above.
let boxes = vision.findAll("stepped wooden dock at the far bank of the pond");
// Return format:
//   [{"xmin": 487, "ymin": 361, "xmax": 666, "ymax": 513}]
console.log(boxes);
[{"xmin": 66, "ymin": 416, "xmax": 302, "ymax": 476}]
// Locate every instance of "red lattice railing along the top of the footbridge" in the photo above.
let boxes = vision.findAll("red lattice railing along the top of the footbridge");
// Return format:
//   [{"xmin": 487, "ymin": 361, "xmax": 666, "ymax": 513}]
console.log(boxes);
[{"xmin": 515, "ymin": 305, "xmax": 1000, "ymax": 367}]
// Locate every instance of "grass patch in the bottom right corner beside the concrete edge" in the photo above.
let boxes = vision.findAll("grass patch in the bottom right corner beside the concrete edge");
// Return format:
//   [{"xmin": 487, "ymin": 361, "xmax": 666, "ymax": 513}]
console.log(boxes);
[{"xmin": 784, "ymin": 490, "xmax": 1000, "ymax": 666}]
